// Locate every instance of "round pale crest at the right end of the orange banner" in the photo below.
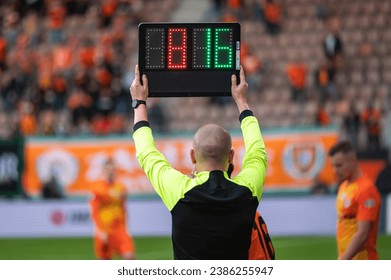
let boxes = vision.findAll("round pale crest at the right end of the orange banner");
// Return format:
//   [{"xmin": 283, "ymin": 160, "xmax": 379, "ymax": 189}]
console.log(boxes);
[{"xmin": 283, "ymin": 141, "xmax": 325, "ymax": 180}]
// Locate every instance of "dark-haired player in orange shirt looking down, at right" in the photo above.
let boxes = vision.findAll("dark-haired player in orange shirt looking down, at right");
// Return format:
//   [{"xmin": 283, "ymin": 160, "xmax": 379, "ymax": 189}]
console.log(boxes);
[{"xmin": 329, "ymin": 141, "xmax": 381, "ymax": 260}]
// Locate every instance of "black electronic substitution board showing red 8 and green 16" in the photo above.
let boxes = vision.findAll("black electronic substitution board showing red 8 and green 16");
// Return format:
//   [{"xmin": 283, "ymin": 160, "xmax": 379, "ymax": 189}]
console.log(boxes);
[{"xmin": 138, "ymin": 23, "xmax": 240, "ymax": 97}]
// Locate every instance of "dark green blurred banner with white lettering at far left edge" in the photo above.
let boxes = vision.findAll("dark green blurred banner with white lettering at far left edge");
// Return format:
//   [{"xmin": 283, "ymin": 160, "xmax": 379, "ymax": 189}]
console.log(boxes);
[{"xmin": 0, "ymin": 139, "xmax": 24, "ymax": 197}]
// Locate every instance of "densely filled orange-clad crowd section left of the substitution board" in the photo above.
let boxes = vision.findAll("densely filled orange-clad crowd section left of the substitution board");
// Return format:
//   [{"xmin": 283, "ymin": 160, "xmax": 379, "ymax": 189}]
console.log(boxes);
[{"xmin": 0, "ymin": 0, "xmax": 178, "ymax": 138}]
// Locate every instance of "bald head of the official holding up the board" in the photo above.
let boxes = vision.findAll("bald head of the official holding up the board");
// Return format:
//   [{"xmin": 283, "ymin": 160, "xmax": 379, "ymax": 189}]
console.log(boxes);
[{"xmin": 193, "ymin": 124, "xmax": 232, "ymax": 164}]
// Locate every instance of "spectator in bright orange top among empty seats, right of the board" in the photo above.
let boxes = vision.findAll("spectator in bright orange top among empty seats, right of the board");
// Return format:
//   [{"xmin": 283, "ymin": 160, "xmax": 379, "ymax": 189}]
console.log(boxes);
[{"xmin": 287, "ymin": 62, "xmax": 307, "ymax": 102}]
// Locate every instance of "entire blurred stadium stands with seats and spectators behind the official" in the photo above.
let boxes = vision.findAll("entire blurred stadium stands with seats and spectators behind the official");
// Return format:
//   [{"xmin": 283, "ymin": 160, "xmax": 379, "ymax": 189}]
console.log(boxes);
[{"xmin": 0, "ymin": 0, "xmax": 391, "ymax": 150}]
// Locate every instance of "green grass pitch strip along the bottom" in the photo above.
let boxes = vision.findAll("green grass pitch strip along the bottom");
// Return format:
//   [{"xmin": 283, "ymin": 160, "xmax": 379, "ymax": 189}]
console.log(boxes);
[{"xmin": 0, "ymin": 235, "xmax": 391, "ymax": 260}]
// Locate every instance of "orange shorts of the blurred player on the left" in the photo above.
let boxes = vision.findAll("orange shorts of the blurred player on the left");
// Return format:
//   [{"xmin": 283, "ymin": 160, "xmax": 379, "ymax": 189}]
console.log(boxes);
[{"xmin": 94, "ymin": 230, "xmax": 135, "ymax": 259}]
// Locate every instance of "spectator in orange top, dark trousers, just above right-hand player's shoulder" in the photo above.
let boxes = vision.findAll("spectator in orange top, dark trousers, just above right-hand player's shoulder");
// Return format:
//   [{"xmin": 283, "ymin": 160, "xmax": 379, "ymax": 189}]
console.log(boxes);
[{"xmin": 361, "ymin": 103, "xmax": 382, "ymax": 150}]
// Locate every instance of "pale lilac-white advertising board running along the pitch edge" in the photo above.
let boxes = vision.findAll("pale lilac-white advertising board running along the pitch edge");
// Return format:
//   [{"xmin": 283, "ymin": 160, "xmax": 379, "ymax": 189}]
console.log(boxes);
[{"xmin": 0, "ymin": 195, "xmax": 337, "ymax": 237}]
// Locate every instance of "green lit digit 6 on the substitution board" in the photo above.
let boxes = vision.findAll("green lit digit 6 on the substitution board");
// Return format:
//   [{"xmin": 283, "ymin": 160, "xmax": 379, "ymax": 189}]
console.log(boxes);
[{"xmin": 214, "ymin": 28, "xmax": 233, "ymax": 68}]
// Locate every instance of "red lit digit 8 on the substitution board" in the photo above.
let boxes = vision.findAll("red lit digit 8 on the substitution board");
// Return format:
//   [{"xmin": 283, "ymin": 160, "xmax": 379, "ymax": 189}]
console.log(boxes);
[{"xmin": 167, "ymin": 28, "xmax": 187, "ymax": 69}]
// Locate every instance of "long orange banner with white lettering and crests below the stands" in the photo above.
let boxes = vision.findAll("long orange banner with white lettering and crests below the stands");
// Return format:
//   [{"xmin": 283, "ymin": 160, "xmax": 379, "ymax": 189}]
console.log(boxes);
[{"xmin": 24, "ymin": 130, "xmax": 337, "ymax": 196}]
